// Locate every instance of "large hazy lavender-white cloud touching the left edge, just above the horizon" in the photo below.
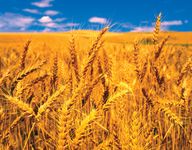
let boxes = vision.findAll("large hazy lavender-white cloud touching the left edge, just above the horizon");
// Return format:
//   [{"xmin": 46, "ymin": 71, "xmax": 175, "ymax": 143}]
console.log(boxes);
[{"xmin": 0, "ymin": 13, "xmax": 35, "ymax": 31}]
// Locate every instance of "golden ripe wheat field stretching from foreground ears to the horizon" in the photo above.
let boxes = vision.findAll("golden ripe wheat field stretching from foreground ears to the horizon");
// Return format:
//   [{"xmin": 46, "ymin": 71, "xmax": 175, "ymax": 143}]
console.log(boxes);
[{"xmin": 0, "ymin": 16, "xmax": 192, "ymax": 150}]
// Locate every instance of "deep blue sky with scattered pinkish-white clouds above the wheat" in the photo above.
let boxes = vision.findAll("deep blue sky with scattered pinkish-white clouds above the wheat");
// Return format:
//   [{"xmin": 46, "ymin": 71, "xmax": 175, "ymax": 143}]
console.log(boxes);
[{"xmin": 0, "ymin": 0, "xmax": 192, "ymax": 32}]
